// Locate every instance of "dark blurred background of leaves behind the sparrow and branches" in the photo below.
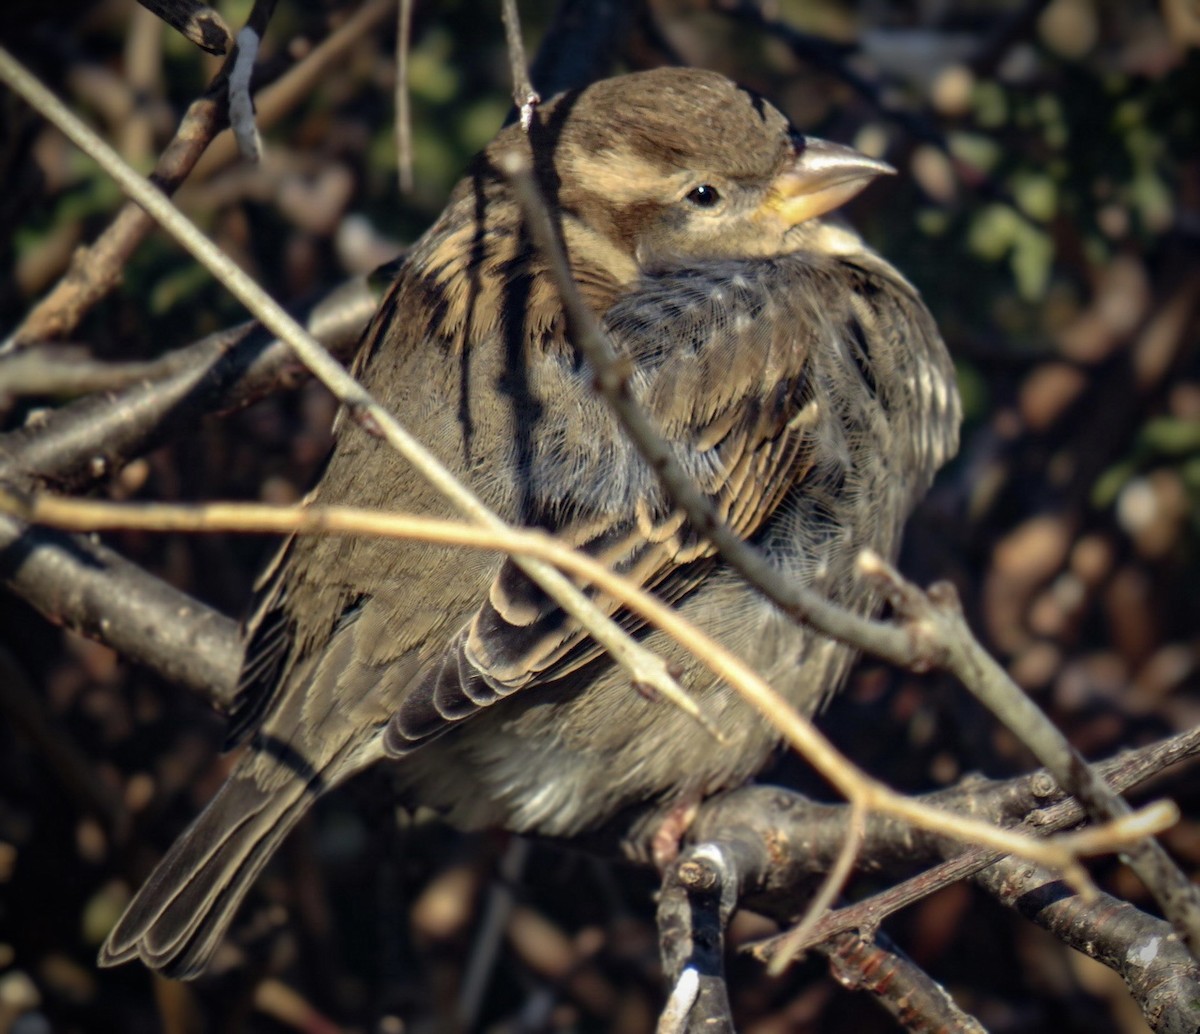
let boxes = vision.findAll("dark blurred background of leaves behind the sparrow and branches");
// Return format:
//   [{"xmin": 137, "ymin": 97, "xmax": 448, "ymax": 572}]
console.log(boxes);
[{"xmin": 0, "ymin": 0, "xmax": 1200, "ymax": 1034}]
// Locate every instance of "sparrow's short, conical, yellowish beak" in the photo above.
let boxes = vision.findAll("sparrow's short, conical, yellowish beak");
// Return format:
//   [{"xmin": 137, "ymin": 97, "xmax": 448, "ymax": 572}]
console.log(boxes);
[{"xmin": 762, "ymin": 137, "xmax": 895, "ymax": 228}]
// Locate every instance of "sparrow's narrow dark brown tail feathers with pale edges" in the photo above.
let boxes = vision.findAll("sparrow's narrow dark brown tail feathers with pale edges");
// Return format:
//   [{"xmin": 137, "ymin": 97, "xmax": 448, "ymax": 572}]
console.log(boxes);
[{"xmin": 97, "ymin": 758, "xmax": 318, "ymax": 980}]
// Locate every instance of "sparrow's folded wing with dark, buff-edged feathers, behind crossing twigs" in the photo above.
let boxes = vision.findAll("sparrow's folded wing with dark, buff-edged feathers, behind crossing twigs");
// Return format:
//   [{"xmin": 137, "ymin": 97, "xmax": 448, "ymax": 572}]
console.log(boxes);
[{"xmin": 385, "ymin": 258, "xmax": 830, "ymax": 756}]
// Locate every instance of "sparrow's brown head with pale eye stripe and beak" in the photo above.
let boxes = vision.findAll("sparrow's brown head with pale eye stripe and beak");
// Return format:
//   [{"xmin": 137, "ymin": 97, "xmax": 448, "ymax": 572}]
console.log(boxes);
[{"xmin": 485, "ymin": 68, "xmax": 893, "ymax": 270}]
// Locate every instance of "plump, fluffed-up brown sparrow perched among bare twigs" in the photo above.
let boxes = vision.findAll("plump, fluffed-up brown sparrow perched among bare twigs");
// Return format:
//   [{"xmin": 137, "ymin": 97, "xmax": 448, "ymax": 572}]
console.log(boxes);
[{"xmin": 100, "ymin": 68, "xmax": 959, "ymax": 976}]
